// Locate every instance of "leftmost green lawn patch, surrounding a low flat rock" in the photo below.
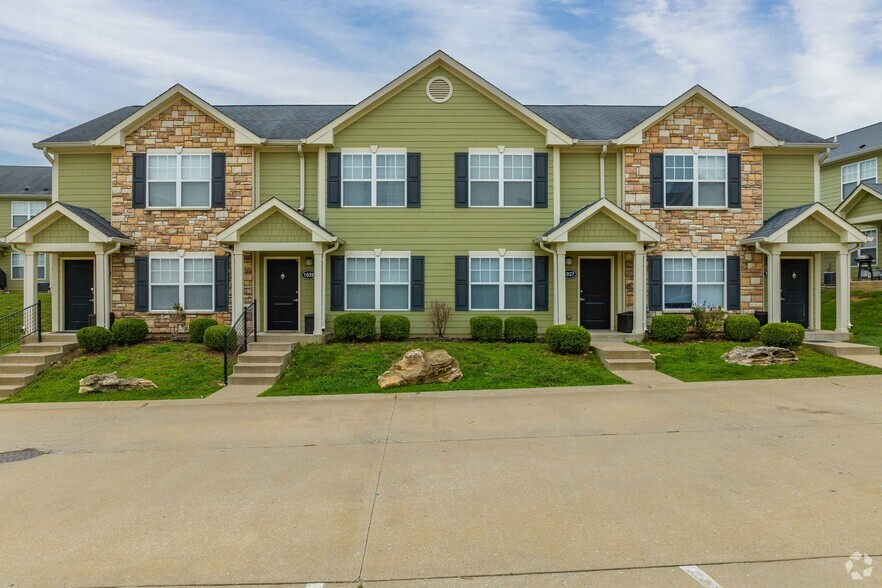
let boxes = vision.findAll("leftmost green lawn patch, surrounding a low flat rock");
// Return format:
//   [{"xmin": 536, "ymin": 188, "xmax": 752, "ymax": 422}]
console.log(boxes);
[{"xmin": 4, "ymin": 342, "xmax": 224, "ymax": 403}]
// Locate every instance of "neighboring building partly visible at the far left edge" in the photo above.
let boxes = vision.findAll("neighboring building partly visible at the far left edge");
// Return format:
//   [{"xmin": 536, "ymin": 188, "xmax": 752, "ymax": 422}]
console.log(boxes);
[{"xmin": 0, "ymin": 165, "xmax": 52, "ymax": 292}]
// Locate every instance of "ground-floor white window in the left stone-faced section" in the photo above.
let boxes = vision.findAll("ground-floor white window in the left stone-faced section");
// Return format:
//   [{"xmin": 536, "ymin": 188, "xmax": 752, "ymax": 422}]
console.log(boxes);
[{"xmin": 150, "ymin": 254, "xmax": 214, "ymax": 312}]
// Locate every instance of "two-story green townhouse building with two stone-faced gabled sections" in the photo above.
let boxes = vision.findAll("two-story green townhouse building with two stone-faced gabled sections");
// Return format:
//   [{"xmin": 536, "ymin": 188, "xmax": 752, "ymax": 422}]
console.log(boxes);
[{"xmin": 8, "ymin": 52, "xmax": 865, "ymax": 336}]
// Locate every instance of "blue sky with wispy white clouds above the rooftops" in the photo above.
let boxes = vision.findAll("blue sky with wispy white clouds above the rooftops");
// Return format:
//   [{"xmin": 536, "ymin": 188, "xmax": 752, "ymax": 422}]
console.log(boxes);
[{"xmin": 0, "ymin": 0, "xmax": 882, "ymax": 165}]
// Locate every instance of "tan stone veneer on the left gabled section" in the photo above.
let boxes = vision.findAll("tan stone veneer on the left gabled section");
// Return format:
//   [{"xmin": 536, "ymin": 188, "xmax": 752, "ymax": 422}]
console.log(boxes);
[{"xmin": 111, "ymin": 99, "xmax": 254, "ymax": 332}]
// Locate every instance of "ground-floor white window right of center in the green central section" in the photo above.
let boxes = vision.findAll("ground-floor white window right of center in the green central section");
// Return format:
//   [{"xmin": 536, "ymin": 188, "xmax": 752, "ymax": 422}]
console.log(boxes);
[{"xmin": 469, "ymin": 253, "xmax": 534, "ymax": 310}]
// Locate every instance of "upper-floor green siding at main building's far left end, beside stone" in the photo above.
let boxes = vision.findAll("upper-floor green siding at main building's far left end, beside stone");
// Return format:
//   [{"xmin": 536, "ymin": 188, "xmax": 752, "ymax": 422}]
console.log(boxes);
[{"xmin": 57, "ymin": 153, "xmax": 111, "ymax": 220}]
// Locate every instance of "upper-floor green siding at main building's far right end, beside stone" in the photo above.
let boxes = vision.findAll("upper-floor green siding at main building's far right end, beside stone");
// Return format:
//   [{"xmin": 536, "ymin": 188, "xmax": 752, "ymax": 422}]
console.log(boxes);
[{"xmin": 763, "ymin": 153, "xmax": 815, "ymax": 219}]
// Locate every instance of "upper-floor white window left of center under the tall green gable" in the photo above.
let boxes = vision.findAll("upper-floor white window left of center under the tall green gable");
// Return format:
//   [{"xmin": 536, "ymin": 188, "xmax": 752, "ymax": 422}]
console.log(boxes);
[{"xmin": 342, "ymin": 149, "xmax": 407, "ymax": 207}]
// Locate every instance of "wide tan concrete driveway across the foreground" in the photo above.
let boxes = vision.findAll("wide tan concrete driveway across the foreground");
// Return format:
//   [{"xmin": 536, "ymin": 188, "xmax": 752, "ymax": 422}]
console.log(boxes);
[{"xmin": 0, "ymin": 376, "xmax": 882, "ymax": 588}]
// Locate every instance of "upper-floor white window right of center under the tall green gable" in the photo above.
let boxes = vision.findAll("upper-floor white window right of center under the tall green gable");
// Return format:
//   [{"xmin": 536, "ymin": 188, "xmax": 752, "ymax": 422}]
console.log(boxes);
[{"xmin": 469, "ymin": 149, "xmax": 533, "ymax": 208}]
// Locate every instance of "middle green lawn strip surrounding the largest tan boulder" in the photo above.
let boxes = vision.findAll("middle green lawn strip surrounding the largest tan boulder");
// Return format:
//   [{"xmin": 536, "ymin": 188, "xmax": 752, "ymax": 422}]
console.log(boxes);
[{"xmin": 263, "ymin": 341, "xmax": 624, "ymax": 396}]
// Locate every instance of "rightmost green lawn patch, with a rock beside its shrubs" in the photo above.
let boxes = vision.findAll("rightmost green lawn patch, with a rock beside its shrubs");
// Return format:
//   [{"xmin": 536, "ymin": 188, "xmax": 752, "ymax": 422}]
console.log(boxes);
[{"xmin": 641, "ymin": 341, "xmax": 882, "ymax": 382}]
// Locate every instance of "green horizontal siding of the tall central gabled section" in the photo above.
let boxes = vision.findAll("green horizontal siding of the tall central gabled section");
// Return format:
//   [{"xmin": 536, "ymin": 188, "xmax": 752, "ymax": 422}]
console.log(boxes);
[{"xmin": 326, "ymin": 69, "xmax": 553, "ymax": 335}]
